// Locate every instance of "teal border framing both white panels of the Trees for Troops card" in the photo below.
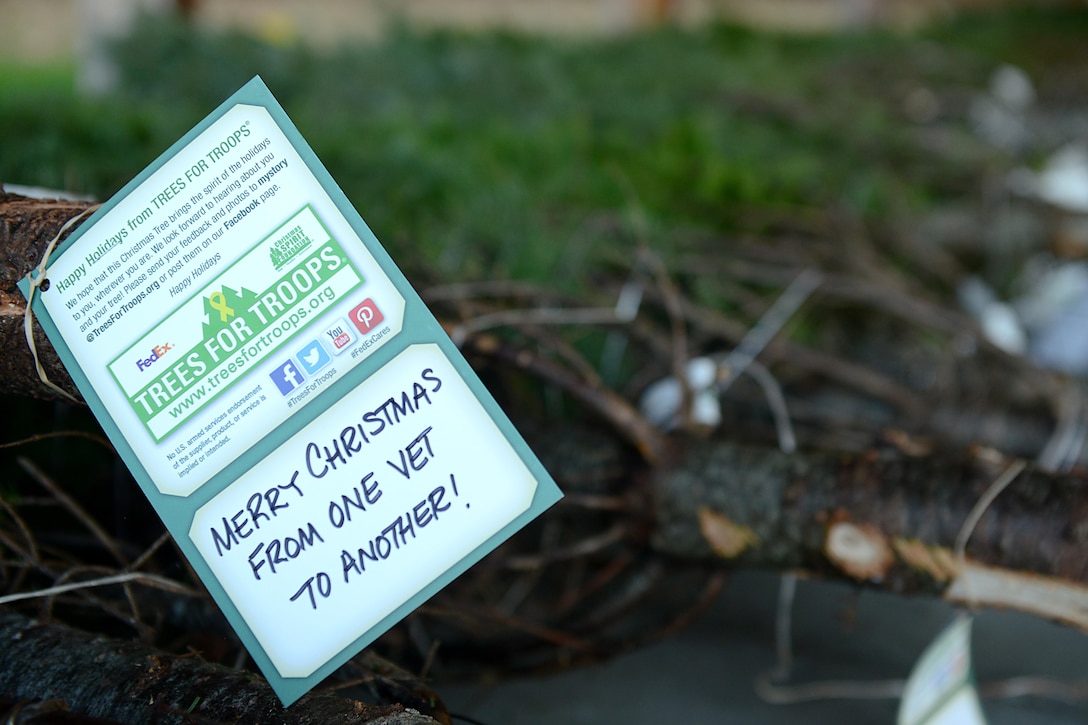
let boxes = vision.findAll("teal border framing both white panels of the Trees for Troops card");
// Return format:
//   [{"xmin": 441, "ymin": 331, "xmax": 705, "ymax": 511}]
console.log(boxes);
[{"xmin": 18, "ymin": 76, "xmax": 562, "ymax": 706}]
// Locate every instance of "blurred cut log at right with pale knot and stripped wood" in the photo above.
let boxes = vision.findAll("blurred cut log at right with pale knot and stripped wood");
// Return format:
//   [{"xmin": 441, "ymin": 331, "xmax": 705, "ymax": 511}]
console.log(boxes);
[{"xmin": 651, "ymin": 440, "xmax": 1088, "ymax": 631}]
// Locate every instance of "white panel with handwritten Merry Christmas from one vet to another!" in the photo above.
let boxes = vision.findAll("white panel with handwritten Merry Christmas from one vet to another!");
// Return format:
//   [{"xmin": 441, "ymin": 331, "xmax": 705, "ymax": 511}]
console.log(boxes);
[{"xmin": 189, "ymin": 345, "xmax": 536, "ymax": 677}]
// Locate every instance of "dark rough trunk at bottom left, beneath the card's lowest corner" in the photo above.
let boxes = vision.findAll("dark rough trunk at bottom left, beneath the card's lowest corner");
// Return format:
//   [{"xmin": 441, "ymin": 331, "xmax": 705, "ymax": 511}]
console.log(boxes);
[{"xmin": 0, "ymin": 612, "xmax": 437, "ymax": 725}]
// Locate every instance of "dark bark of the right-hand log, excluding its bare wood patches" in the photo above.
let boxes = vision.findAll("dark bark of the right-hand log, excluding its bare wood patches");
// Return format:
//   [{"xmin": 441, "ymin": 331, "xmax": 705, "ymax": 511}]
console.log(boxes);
[{"xmin": 654, "ymin": 440, "xmax": 1088, "ymax": 574}]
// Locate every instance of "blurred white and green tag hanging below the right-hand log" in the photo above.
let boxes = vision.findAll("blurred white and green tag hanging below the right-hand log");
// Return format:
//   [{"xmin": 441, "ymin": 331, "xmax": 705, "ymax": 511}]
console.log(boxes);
[{"xmin": 897, "ymin": 616, "xmax": 986, "ymax": 725}]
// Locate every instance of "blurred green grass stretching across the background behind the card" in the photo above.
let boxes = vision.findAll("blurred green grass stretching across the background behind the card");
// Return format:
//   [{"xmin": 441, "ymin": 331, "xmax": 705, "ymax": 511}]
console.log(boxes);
[{"xmin": 0, "ymin": 4, "xmax": 1086, "ymax": 292}]
